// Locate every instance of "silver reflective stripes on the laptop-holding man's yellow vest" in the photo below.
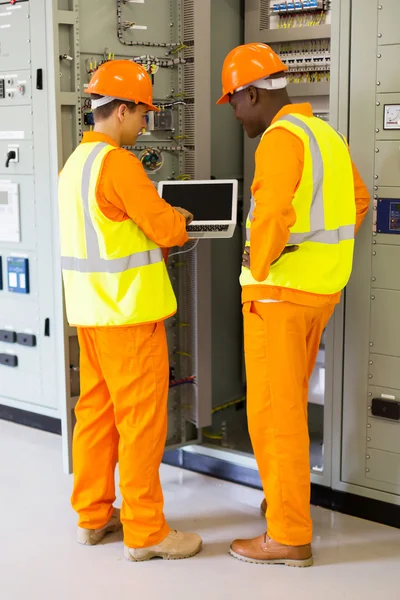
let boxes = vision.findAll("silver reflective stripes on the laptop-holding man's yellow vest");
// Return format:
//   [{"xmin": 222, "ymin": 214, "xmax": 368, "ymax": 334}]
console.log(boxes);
[{"xmin": 61, "ymin": 143, "xmax": 163, "ymax": 273}]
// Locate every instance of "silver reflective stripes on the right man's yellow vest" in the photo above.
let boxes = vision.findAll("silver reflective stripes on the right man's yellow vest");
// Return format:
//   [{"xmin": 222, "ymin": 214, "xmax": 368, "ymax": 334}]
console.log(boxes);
[{"xmin": 246, "ymin": 115, "xmax": 355, "ymax": 245}]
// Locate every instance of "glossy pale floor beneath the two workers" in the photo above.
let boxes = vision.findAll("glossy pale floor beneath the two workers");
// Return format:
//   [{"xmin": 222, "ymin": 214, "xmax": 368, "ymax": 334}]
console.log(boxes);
[{"xmin": 0, "ymin": 421, "xmax": 400, "ymax": 600}]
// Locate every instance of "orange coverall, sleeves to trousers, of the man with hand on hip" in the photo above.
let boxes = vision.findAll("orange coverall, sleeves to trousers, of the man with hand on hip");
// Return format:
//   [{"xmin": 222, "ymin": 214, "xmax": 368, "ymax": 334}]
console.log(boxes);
[{"xmin": 243, "ymin": 104, "xmax": 370, "ymax": 546}]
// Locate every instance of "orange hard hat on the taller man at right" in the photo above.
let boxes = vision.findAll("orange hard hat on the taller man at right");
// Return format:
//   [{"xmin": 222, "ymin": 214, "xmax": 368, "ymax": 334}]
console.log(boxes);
[{"xmin": 217, "ymin": 43, "xmax": 287, "ymax": 104}]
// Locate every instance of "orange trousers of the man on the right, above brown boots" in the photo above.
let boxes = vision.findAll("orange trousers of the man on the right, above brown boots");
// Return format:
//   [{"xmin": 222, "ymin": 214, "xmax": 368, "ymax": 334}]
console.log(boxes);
[{"xmin": 243, "ymin": 302, "xmax": 335, "ymax": 546}]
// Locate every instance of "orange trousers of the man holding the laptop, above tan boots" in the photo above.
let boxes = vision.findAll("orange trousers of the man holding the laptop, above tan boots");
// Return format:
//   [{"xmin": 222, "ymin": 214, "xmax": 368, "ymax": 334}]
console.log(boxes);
[{"xmin": 71, "ymin": 322, "xmax": 170, "ymax": 548}]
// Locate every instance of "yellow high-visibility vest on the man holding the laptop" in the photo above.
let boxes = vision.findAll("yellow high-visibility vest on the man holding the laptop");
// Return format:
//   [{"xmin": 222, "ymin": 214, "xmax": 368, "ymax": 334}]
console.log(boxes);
[{"xmin": 58, "ymin": 142, "xmax": 177, "ymax": 327}]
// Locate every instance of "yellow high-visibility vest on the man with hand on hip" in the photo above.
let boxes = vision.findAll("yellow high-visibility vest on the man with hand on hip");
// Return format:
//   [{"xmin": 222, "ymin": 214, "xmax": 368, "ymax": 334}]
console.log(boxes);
[{"xmin": 240, "ymin": 114, "xmax": 356, "ymax": 295}]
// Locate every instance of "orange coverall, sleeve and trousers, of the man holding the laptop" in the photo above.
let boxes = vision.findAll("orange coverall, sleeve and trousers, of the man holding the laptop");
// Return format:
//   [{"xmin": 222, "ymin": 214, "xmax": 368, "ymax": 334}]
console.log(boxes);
[{"xmin": 72, "ymin": 132, "xmax": 188, "ymax": 548}]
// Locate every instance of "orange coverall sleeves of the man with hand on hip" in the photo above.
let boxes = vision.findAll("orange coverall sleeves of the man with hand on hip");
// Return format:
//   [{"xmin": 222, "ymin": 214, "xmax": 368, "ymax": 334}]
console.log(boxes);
[{"xmin": 250, "ymin": 129, "xmax": 370, "ymax": 281}]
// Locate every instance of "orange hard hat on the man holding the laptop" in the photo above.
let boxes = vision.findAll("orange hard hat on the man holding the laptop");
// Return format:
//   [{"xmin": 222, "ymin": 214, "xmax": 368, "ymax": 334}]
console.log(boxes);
[{"xmin": 85, "ymin": 60, "xmax": 160, "ymax": 111}]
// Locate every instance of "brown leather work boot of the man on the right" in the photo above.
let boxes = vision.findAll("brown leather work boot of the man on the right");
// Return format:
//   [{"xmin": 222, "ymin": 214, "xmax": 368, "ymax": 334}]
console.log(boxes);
[{"xmin": 230, "ymin": 533, "xmax": 314, "ymax": 567}]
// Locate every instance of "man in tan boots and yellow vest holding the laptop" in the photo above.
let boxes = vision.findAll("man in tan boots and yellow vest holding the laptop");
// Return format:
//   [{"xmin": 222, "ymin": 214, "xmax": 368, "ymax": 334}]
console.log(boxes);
[{"xmin": 59, "ymin": 60, "xmax": 202, "ymax": 561}]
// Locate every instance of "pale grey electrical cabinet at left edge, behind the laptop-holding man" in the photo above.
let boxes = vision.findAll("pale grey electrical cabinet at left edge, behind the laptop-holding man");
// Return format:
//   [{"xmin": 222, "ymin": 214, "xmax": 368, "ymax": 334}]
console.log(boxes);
[{"xmin": 0, "ymin": 0, "xmax": 61, "ymax": 426}]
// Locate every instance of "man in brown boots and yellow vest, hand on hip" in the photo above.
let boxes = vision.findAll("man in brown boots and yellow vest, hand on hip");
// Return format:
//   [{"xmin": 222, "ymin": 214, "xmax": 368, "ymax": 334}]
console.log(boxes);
[{"xmin": 219, "ymin": 43, "xmax": 370, "ymax": 567}]
